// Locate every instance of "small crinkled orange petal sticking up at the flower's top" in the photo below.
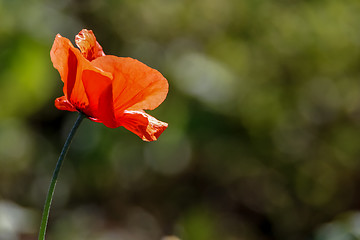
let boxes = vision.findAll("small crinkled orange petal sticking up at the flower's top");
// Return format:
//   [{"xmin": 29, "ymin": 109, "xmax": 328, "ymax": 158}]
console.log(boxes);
[{"xmin": 75, "ymin": 29, "xmax": 105, "ymax": 61}]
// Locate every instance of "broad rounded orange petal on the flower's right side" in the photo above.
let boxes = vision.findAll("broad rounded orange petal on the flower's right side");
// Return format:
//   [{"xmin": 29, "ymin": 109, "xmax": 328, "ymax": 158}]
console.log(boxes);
[{"xmin": 91, "ymin": 55, "xmax": 169, "ymax": 116}]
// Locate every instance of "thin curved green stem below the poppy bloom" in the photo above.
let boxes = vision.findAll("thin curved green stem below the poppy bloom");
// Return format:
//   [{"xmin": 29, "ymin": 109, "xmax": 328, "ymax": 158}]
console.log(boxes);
[{"xmin": 39, "ymin": 112, "xmax": 85, "ymax": 240}]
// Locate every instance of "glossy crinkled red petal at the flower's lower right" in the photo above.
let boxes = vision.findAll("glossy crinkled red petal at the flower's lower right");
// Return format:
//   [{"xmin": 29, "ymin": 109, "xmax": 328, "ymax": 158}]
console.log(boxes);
[{"xmin": 119, "ymin": 111, "xmax": 168, "ymax": 141}]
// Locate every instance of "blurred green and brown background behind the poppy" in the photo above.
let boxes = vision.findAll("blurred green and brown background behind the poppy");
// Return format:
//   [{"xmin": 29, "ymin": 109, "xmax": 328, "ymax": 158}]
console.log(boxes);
[{"xmin": 0, "ymin": 0, "xmax": 360, "ymax": 240}]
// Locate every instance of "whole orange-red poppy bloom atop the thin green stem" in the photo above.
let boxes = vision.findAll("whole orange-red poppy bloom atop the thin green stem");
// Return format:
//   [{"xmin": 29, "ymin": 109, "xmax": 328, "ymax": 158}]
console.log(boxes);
[{"xmin": 50, "ymin": 29, "xmax": 169, "ymax": 141}]
